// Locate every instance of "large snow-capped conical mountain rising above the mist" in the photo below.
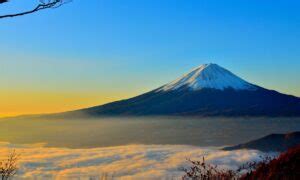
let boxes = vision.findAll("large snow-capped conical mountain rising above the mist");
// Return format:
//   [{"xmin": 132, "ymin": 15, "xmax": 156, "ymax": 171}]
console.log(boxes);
[{"xmin": 64, "ymin": 64, "xmax": 300, "ymax": 116}]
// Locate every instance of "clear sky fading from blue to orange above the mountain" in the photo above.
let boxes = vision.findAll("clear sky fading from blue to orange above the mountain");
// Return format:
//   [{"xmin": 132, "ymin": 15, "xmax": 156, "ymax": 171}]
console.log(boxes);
[{"xmin": 0, "ymin": 0, "xmax": 300, "ymax": 117}]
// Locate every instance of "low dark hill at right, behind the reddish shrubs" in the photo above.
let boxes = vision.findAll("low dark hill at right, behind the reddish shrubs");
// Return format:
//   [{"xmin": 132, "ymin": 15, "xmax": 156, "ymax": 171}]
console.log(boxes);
[{"xmin": 223, "ymin": 131, "xmax": 300, "ymax": 152}]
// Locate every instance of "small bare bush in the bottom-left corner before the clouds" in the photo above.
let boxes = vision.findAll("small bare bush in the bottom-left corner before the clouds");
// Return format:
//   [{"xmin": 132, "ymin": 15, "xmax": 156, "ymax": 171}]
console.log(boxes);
[{"xmin": 0, "ymin": 151, "xmax": 19, "ymax": 180}]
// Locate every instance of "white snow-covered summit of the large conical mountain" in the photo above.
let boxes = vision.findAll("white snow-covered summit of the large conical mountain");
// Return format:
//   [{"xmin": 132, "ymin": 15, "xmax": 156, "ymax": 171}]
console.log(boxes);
[{"xmin": 158, "ymin": 63, "xmax": 256, "ymax": 91}]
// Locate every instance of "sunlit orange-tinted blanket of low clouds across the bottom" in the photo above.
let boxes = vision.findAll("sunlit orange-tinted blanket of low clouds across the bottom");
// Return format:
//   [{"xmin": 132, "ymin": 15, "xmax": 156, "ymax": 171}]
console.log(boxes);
[{"xmin": 0, "ymin": 142, "xmax": 264, "ymax": 179}]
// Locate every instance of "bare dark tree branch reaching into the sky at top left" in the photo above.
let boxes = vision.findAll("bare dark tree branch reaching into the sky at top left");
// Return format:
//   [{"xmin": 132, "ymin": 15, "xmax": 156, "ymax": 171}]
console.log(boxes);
[{"xmin": 0, "ymin": 0, "xmax": 72, "ymax": 19}]
